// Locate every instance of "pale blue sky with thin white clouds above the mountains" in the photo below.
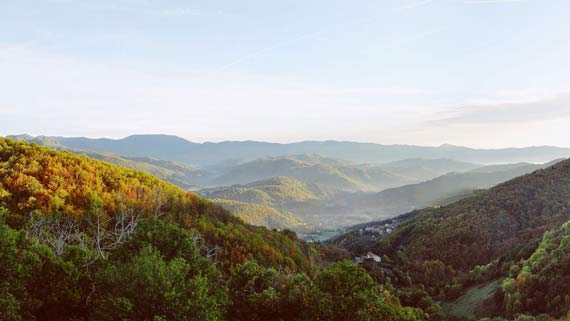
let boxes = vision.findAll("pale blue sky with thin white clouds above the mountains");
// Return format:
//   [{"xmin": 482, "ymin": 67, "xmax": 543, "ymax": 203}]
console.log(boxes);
[{"xmin": 0, "ymin": 0, "xmax": 570, "ymax": 148}]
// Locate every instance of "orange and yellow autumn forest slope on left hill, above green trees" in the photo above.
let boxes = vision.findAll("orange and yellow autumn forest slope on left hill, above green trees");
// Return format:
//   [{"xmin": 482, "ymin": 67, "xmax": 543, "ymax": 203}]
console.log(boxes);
[{"xmin": 0, "ymin": 139, "xmax": 310, "ymax": 269}]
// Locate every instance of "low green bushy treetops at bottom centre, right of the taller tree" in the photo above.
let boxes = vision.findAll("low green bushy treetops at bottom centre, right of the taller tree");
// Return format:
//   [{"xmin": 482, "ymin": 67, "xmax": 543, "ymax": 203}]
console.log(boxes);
[{"xmin": 224, "ymin": 261, "xmax": 427, "ymax": 321}]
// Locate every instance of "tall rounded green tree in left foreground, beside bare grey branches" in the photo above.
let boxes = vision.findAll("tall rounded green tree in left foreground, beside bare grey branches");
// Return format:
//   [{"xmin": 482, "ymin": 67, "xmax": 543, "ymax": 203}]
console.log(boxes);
[{"xmin": 91, "ymin": 219, "xmax": 226, "ymax": 321}]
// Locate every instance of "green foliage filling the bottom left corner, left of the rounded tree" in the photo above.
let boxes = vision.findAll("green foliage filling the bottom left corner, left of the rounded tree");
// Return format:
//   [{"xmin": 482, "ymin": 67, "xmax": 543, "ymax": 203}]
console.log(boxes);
[{"xmin": 0, "ymin": 211, "xmax": 89, "ymax": 320}]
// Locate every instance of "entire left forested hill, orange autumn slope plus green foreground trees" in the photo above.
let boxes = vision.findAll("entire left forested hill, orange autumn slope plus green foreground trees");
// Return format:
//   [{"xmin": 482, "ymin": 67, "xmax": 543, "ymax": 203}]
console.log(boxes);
[{"xmin": 0, "ymin": 139, "xmax": 422, "ymax": 321}]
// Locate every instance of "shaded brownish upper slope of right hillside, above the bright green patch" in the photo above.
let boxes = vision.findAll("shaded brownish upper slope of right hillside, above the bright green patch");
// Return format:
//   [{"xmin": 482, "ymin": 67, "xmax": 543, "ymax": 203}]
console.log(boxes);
[{"xmin": 390, "ymin": 161, "xmax": 570, "ymax": 270}]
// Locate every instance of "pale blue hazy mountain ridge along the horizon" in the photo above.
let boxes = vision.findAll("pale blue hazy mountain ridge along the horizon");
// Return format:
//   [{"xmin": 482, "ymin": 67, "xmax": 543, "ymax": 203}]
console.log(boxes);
[{"xmin": 9, "ymin": 135, "xmax": 570, "ymax": 166}]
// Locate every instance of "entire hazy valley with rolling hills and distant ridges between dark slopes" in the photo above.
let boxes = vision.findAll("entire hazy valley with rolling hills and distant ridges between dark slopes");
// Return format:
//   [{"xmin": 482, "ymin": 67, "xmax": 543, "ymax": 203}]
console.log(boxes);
[{"xmin": 12, "ymin": 135, "xmax": 570, "ymax": 235}]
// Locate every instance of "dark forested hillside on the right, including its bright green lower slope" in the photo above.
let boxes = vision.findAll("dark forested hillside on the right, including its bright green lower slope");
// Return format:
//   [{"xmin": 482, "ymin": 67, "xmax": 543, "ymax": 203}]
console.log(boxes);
[{"xmin": 335, "ymin": 156, "xmax": 570, "ymax": 319}]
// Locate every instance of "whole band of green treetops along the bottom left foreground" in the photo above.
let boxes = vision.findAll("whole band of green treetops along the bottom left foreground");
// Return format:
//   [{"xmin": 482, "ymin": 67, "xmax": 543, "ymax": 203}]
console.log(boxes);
[{"xmin": 0, "ymin": 212, "xmax": 426, "ymax": 321}]
